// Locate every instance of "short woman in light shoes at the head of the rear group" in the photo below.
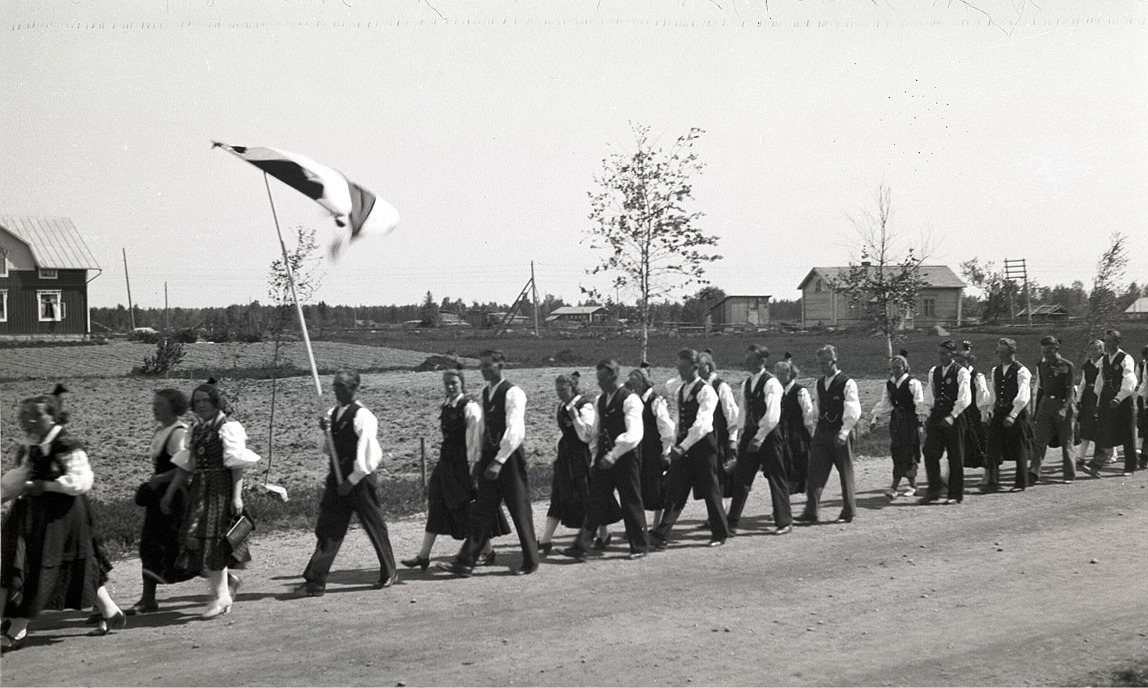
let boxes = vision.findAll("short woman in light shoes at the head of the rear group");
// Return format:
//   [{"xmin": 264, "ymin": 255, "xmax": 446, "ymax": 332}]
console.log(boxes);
[{"xmin": 869, "ymin": 349, "xmax": 924, "ymax": 500}]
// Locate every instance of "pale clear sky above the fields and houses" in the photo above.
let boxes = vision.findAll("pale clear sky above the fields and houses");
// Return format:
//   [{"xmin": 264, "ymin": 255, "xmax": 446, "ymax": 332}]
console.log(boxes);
[{"xmin": 0, "ymin": 0, "xmax": 1148, "ymax": 307}]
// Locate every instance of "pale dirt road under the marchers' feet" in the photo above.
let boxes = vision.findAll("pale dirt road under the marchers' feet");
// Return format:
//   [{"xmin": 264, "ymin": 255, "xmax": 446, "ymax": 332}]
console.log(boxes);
[{"xmin": 2, "ymin": 459, "xmax": 1148, "ymax": 686}]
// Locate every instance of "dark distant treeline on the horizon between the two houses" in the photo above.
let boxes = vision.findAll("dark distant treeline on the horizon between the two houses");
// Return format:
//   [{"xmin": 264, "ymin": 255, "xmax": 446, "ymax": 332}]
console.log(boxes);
[{"xmin": 92, "ymin": 287, "xmax": 801, "ymax": 341}]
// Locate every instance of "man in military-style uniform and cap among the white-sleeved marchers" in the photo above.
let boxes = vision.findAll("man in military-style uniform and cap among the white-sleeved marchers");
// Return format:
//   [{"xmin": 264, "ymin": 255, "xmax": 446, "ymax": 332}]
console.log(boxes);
[{"xmin": 1029, "ymin": 335, "xmax": 1076, "ymax": 485}]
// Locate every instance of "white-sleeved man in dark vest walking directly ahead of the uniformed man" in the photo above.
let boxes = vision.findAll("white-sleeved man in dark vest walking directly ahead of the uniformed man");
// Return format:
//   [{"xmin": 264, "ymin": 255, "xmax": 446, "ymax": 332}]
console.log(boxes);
[{"xmin": 986, "ymin": 337, "xmax": 1032, "ymax": 492}]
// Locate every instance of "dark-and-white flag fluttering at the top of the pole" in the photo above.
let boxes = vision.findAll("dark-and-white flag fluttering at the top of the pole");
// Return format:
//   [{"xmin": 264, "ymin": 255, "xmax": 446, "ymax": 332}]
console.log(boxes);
[{"xmin": 211, "ymin": 141, "xmax": 398, "ymax": 257}]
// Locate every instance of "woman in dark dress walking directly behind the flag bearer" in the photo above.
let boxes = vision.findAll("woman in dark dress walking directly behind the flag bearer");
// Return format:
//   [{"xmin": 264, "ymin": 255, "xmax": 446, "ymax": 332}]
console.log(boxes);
[{"xmin": 400, "ymin": 370, "xmax": 510, "ymax": 571}]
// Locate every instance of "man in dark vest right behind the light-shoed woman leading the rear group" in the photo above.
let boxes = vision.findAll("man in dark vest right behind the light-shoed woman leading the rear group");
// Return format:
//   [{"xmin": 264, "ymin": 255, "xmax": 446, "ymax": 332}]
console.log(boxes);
[{"xmin": 917, "ymin": 339, "xmax": 972, "ymax": 504}]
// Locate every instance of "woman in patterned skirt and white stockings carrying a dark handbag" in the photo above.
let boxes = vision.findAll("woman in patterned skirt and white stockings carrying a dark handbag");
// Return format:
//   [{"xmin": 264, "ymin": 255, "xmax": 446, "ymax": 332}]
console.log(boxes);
[{"xmin": 160, "ymin": 378, "xmax": 259, "ymax": 619}]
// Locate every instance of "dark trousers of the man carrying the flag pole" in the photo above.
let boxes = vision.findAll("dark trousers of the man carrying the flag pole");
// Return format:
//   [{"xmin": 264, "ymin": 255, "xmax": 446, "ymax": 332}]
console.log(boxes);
[{"xmin": 303, "ymin": 473, "xmax": 395, "ymax": 587}]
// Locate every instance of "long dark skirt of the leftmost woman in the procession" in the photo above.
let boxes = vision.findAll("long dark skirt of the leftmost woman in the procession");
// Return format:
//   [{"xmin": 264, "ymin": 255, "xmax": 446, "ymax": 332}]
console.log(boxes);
[{"xmin": 0, "ymin": 493, "xmax": 105, "ymax": 619}]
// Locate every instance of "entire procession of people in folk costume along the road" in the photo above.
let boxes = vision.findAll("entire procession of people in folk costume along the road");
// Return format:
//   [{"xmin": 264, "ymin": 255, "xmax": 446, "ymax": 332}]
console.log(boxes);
[{"xmin": 0, "ymin": 330, "xmax": 1148, "ymax": 652}]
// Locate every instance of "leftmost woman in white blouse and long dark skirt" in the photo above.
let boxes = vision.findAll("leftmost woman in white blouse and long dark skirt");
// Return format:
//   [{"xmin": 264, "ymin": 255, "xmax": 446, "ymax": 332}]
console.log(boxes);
[{"xmin": 0, "ymin": 385, "xmax": 126, "ymax": 652}]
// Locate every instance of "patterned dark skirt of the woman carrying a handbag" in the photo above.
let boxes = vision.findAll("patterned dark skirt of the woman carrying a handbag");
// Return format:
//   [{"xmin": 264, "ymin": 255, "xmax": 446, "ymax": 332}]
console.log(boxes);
[{"xmin": 176, "ymin": 469, "xmax": 251, "ymax": 572}]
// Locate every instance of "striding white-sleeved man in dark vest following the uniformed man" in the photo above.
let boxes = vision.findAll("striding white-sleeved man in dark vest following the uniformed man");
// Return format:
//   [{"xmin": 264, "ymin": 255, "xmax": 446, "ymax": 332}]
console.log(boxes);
[{"xmin": 1085, "ymin": 330, "xmax": 1137, "ymax": 477}]
